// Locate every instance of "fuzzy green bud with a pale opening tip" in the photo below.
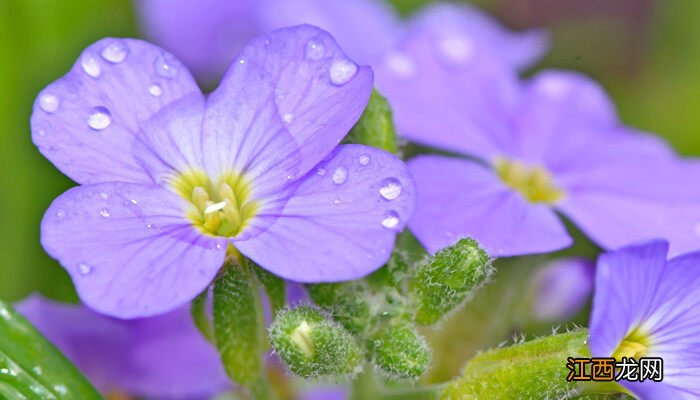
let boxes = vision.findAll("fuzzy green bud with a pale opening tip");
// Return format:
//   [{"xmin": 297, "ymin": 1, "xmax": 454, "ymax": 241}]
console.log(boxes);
[{"xmin": 268, "ymin": 307, "xmax": 361, "ymax": 377}]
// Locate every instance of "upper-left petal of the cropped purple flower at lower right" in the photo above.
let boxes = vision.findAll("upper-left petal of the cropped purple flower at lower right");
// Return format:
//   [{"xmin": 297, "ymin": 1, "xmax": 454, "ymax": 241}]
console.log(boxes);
[{"xmin": 589, "ymin": 241, "xmax": 668, "ymax": 357}]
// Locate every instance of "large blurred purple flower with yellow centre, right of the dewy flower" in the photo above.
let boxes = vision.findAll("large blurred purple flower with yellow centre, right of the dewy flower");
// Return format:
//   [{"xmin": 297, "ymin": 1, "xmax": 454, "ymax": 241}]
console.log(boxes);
[{"xmin": 376, "ymin": 29, "xmax": 700, "ymax": 256}]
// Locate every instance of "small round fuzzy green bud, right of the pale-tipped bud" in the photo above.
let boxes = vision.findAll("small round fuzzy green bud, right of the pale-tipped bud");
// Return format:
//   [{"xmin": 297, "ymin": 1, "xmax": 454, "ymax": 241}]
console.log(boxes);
[{"xmin": 368, "ymin": 323, "xmax": 432, "ymax": 379}]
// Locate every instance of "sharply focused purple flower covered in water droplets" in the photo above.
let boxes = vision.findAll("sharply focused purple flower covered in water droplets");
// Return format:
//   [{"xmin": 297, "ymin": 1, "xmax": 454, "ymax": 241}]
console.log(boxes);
[{"xmin": 32, "ymin": 26, "xmax": 414, "ymax": 318}]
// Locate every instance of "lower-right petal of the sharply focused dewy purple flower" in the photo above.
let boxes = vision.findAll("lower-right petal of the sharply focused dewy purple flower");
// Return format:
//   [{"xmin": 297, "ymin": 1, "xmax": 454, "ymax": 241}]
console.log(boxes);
[{"xmin": 234, "ymin": 145, "xmax": 415, "ymax": 282}]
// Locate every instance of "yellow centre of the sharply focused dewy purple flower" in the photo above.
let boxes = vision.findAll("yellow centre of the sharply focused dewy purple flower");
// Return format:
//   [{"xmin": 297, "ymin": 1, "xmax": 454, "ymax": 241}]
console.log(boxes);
[{"xmin": 169, "ymin": 171, "xmax": 259, "ymax": 237}]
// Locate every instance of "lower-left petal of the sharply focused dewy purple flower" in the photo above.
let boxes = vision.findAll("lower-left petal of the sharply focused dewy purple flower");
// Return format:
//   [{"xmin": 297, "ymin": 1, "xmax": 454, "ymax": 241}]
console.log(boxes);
[{"xmin": 41, "ymin": 183, "xmax": 226, "ymax": 318}]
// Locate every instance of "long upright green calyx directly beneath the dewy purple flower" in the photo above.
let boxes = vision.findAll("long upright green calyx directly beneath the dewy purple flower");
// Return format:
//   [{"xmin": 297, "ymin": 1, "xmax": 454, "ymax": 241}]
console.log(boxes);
[{"xmin": 214, "ymin": 264, "xmax": 265, "ymax": 388}]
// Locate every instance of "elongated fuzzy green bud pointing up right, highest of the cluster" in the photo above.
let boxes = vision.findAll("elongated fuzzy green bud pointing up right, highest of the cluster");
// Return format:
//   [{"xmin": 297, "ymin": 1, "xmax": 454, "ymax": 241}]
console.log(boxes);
[{"xmin": 411, "ymin": 239, "xmax": 493, "ymax": 325}]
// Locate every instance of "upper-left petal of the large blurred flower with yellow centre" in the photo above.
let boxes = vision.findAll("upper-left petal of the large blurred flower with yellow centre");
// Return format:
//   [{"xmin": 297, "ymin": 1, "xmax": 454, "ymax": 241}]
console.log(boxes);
[{"xmin": 376, "ymin": 28, "xmax": 519, "ymax": 159}]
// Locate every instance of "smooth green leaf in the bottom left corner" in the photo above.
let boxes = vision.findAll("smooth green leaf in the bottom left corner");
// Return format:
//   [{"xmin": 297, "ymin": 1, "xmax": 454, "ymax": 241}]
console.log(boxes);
[{"xmin": 0, "ymin": 301, "xmax": 102, "ymax": 400}]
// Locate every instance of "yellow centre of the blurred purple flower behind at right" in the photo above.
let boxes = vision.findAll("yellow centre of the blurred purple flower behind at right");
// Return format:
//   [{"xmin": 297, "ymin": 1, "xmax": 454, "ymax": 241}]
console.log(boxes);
[{"xmin": 494, "ymin": 158, "xmax": 564, "ymax": 204}]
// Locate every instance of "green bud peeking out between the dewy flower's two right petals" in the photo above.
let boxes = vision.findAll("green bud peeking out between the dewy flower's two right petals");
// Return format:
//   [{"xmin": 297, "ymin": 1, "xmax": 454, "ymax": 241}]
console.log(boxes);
[{"xmin": 345, "ymin": 89, "xmax": 399, "ymax": 154}]
